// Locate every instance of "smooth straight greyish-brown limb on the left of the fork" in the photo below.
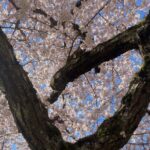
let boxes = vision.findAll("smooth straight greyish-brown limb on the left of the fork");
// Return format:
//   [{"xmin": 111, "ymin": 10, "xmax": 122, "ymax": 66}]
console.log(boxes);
[{"xmin": 0, "ymin": 29, "xmax": 74, "ymax": 150}]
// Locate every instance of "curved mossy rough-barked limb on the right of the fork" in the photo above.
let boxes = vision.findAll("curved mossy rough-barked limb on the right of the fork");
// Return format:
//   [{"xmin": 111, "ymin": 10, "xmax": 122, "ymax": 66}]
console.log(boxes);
[{"xmin": 76, "ymin": 15, "xmax": 150, "ymax": 150}]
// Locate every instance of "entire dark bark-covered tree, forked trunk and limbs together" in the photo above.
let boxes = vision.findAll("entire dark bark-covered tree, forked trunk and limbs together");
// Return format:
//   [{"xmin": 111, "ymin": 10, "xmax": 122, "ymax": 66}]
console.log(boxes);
[{"xmin": 0, "ymin": 12, "xmax": 150, "ymax": 150}]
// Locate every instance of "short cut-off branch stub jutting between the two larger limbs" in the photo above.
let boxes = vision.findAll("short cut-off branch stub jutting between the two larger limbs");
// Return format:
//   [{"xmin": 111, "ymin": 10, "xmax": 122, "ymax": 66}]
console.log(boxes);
[{"xmin": 48, "ymin": 14, "xmax": 149, "ymax": 103}]
